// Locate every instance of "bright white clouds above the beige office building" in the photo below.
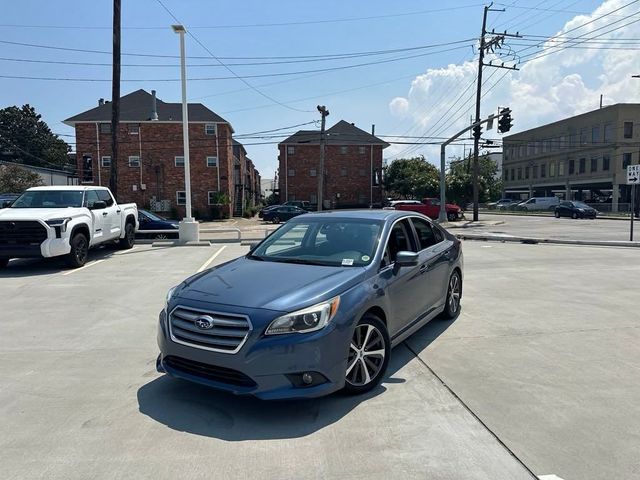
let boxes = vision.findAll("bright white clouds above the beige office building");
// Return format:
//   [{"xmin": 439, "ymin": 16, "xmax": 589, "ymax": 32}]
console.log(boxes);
[{"xmin": 385, "ymin": 0, "xmax": 640, "ymax": 162}]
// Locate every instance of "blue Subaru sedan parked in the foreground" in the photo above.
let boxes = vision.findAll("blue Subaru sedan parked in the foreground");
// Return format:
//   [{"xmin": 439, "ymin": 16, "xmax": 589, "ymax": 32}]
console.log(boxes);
[{"xmin": 157, "ymin": 210, "xmax": 463, "ymax": 399}]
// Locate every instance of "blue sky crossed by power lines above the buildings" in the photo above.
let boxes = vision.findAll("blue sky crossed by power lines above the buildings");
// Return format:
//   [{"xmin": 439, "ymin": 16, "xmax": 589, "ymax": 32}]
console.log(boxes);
[{"xmin": 0, "ymin": 0, "xmax": 628, "ymax": 178}]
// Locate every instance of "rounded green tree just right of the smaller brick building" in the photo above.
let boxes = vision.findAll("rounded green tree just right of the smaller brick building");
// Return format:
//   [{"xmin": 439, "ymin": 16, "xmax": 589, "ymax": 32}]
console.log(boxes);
[{"xmin": 385, "ymin": 156, "xmax": 440, "ymax": 199}]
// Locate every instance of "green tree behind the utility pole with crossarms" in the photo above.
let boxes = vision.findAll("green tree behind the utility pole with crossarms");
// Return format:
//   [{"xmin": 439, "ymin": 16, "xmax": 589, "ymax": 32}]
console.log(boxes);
[{"xmin": 446, "ymin": 154, "xmax": 502, "ymax": 206}]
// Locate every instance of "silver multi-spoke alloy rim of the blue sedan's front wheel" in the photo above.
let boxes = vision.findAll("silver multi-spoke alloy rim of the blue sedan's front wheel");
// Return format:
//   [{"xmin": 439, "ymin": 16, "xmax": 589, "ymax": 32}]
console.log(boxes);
[{"xmin": 346, "ymin": 323, "xmax": 386, "ymax": 386}]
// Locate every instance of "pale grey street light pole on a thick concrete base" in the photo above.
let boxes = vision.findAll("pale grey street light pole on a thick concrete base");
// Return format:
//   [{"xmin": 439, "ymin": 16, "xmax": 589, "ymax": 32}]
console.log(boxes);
[{"xmin": 171, "ymin": 25, "xmax": 199, "ymax": 242}]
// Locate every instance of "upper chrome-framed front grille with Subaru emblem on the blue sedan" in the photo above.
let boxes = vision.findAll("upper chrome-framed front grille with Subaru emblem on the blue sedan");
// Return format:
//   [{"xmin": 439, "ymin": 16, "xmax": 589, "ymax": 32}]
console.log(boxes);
[{"xmin": 169, "ymin": 306, "xmax": 252, "ymax": 353}]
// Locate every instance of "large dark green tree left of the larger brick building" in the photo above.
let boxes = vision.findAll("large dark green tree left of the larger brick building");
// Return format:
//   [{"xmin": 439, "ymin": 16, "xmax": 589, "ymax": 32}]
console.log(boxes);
[{"xmin": 0, "ymin": 105, "xmax": 71, "ymax": 168}]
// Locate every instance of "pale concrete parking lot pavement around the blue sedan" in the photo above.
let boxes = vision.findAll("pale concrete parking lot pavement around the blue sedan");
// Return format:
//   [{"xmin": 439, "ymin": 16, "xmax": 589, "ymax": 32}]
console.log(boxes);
[{"xmin": 0, "ymin": 242, "xmax": 640, "ymax": 480}]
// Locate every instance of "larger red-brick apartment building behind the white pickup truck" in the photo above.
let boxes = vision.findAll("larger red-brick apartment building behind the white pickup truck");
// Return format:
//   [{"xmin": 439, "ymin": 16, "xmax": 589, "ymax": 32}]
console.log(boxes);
[{"xmin": 64, "ymin": 90, "xmax": 259, "ymax": 218}]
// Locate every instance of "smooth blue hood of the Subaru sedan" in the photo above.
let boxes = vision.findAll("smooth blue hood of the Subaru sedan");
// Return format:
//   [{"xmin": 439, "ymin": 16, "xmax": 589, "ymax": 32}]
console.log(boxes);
[{"xmin": 176, "ymin": 257, "xmax": 366, "ymax": 312}]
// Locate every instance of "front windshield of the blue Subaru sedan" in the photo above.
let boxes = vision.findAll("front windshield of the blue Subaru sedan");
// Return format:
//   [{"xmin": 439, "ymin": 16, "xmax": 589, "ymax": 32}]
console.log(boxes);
[{"xmin": 249, "ymin": 218, "xmax": 382, "ymax": 267}]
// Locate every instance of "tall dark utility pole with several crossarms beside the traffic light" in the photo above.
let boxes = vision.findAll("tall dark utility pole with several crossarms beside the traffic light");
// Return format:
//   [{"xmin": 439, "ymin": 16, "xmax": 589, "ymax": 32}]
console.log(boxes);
[{"xmin": 473, "ymin": 2, "xmax": 521, "ymax": 222}]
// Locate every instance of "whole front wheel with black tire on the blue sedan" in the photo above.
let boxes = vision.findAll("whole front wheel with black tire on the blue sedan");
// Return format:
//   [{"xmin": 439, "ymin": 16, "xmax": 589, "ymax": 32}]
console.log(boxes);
[{"xmin": 344, "ymin": 313, "xmax": 391, "ymax": 395}]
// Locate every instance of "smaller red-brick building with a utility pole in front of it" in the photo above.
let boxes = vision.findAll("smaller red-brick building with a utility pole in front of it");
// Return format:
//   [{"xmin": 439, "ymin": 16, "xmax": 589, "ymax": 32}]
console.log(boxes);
[{"xmin": 278, "ymin": 120, "xmax": 389, "ymax": 208}]
